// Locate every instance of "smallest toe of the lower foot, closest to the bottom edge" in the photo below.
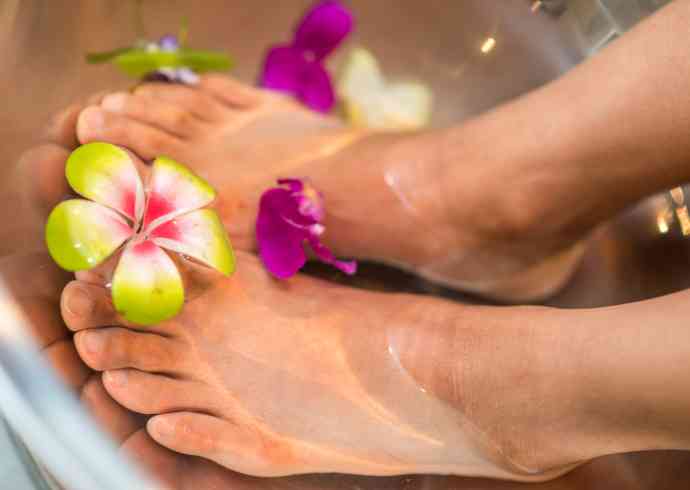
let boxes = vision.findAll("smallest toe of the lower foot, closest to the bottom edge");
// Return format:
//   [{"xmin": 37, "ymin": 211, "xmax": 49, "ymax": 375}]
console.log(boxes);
[{"xmin": 146, "ymin": 412, "xmax": 299, "ymax": 476}]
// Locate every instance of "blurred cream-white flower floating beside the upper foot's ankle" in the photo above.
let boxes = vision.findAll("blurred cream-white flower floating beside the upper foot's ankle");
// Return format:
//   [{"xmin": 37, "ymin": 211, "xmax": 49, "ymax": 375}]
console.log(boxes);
[{"xmin": 337, "ymin": 48, "xmax": 432, "ymax": 130}]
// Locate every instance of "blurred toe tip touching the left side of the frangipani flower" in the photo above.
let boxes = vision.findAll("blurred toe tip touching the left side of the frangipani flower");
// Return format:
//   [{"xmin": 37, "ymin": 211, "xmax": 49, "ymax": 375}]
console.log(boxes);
[{"xmin": 17, "ymin": 143, "xmax": 69, "ymax": 216}]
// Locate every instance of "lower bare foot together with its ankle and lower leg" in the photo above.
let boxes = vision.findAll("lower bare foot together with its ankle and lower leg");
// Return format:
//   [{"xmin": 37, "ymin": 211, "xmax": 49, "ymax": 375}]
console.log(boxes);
[{"xmin": 57, "ymin": 254, "xmax": 690, "ymax": 480}]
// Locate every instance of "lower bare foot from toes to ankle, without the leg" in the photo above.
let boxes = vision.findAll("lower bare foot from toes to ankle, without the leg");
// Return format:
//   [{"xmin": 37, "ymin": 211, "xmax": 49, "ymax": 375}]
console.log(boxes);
[{"xmin": 62, "ymin": 253, "xmax": 592, "ymax": 480}]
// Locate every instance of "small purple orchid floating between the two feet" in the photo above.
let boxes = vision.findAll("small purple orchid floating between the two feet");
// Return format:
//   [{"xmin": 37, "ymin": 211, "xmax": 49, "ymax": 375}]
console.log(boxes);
[{"xmin": 256, "ymin": 179, "xmax": 357, "ymax": 279}]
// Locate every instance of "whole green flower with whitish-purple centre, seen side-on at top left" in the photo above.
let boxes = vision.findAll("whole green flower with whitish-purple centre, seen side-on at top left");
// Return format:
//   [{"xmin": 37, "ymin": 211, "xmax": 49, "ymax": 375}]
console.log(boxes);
[{"xmin": 86, "ymin": 35, "xmax": 232, "ymax": 84}]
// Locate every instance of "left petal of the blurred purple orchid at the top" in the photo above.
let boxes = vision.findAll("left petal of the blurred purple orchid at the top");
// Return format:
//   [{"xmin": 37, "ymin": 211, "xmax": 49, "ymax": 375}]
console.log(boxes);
[{"xmin": 260, "ymin": 46, "xmax": 307, "ymax": 95}]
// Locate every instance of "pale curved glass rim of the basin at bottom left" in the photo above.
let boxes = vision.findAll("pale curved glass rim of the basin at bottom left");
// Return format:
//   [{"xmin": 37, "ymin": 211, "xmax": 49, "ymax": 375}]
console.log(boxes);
[{"xmin": 0, "ymin": 282, "xmax": 163, "ymax": 490}]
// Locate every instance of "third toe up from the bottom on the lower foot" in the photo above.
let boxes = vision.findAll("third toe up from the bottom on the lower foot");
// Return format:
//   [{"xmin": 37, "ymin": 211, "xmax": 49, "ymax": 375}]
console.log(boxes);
[{"xmin": 74, "ymin": 328, "xmax": 185, "ymax": 374}]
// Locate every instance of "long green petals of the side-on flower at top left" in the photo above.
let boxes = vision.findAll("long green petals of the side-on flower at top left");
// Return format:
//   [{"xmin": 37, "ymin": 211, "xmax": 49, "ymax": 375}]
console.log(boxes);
[{"xmin": 114, "ymin": 49, "xmax": 233, "ymax": 78}]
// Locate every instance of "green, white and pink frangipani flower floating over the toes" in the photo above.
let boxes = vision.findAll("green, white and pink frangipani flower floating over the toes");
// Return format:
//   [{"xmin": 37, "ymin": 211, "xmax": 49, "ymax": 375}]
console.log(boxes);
[{"xmin": 46, "ymin": 143, "xmax": 235, "ymax": 325}]
